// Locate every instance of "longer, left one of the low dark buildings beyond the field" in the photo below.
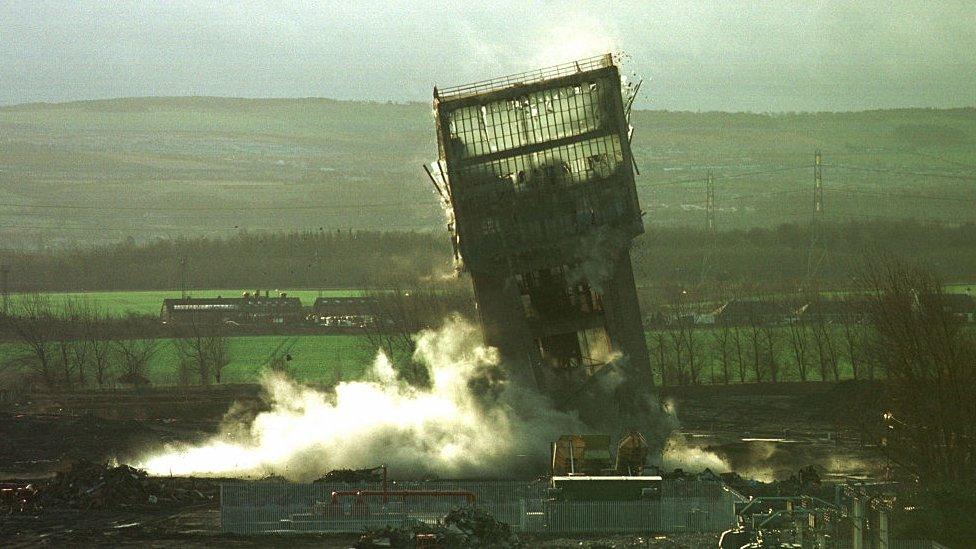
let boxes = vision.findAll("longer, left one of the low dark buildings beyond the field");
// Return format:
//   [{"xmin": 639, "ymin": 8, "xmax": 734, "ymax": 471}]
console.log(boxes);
[{"xmin": 159, "ymin": 293, "xmax": 304, "ymax": 324}]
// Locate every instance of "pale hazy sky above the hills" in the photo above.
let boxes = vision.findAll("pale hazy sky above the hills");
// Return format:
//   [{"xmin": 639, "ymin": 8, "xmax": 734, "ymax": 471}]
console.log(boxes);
[{"xmin": 0, "ymin": 0, "xmax": 976, "ymax": 111}]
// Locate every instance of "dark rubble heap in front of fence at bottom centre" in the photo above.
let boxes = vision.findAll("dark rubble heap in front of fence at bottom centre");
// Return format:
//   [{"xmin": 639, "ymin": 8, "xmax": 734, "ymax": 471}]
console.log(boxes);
[{"xmin": 356, "ymin": 507, "xmax": 521, "ymax": 549}]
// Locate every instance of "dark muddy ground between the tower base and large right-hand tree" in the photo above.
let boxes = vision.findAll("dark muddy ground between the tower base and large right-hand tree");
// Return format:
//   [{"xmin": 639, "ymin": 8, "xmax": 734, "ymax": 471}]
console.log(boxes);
[{"xmin": 661, "ymin": 381, "xmax": 884, "ymax": 481}]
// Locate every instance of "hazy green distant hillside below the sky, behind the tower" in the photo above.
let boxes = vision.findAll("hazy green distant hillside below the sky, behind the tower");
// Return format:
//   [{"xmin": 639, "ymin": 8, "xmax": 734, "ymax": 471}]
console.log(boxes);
[{"xmin": 0, "ymin": 97, "xmax": 976, "ymax": 247}]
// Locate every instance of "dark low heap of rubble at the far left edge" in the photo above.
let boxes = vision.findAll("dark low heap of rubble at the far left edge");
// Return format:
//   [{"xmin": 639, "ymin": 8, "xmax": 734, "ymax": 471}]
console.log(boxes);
[{"xmin": 3, "ymin": 460, "xmax": 210, "ymax": 512}]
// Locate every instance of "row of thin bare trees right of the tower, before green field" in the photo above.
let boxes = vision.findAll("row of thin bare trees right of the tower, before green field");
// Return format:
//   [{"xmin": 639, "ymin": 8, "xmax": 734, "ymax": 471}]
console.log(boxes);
[{"xmin": 645, "ymin": 291, "xmax": 876, "ymax": 385}]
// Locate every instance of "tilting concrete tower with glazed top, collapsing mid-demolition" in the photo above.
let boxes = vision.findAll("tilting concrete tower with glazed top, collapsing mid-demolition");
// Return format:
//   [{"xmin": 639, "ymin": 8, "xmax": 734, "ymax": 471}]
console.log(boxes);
[{"xmin": 434, "ymin": 55, "xmax": 651, "ymax": 397}]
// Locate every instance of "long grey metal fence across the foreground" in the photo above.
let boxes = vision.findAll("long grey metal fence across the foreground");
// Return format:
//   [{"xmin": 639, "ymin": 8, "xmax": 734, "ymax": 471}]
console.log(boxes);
[{"xmin": 220, "ymin": 481, "xmax": 738, "ymax": 534}]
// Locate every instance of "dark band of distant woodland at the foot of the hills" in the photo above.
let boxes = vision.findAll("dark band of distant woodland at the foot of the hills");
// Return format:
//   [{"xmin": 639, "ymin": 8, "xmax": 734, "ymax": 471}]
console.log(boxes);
[{"xmin": 0, "ymin": 220, "xmax": 976, "ymax": 299}]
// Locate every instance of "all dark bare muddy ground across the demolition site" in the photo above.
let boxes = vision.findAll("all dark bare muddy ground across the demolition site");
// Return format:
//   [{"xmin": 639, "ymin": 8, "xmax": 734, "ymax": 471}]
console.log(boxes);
[{"xmin": 0, "ymin": 382, "xmax": 881, "ymax": 547}]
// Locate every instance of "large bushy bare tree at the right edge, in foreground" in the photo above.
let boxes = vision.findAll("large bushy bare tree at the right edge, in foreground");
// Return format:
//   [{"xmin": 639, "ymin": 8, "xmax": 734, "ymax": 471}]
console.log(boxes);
[{"xmin": 864, "ymin": 258, "xmax": 976, "ymax": 486}]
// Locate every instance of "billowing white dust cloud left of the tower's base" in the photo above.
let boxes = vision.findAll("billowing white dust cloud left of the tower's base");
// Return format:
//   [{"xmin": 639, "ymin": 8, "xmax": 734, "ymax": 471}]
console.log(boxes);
[{"xmin": 137, "ymin": 317, "xmax": 587, "ymax": 480}]
